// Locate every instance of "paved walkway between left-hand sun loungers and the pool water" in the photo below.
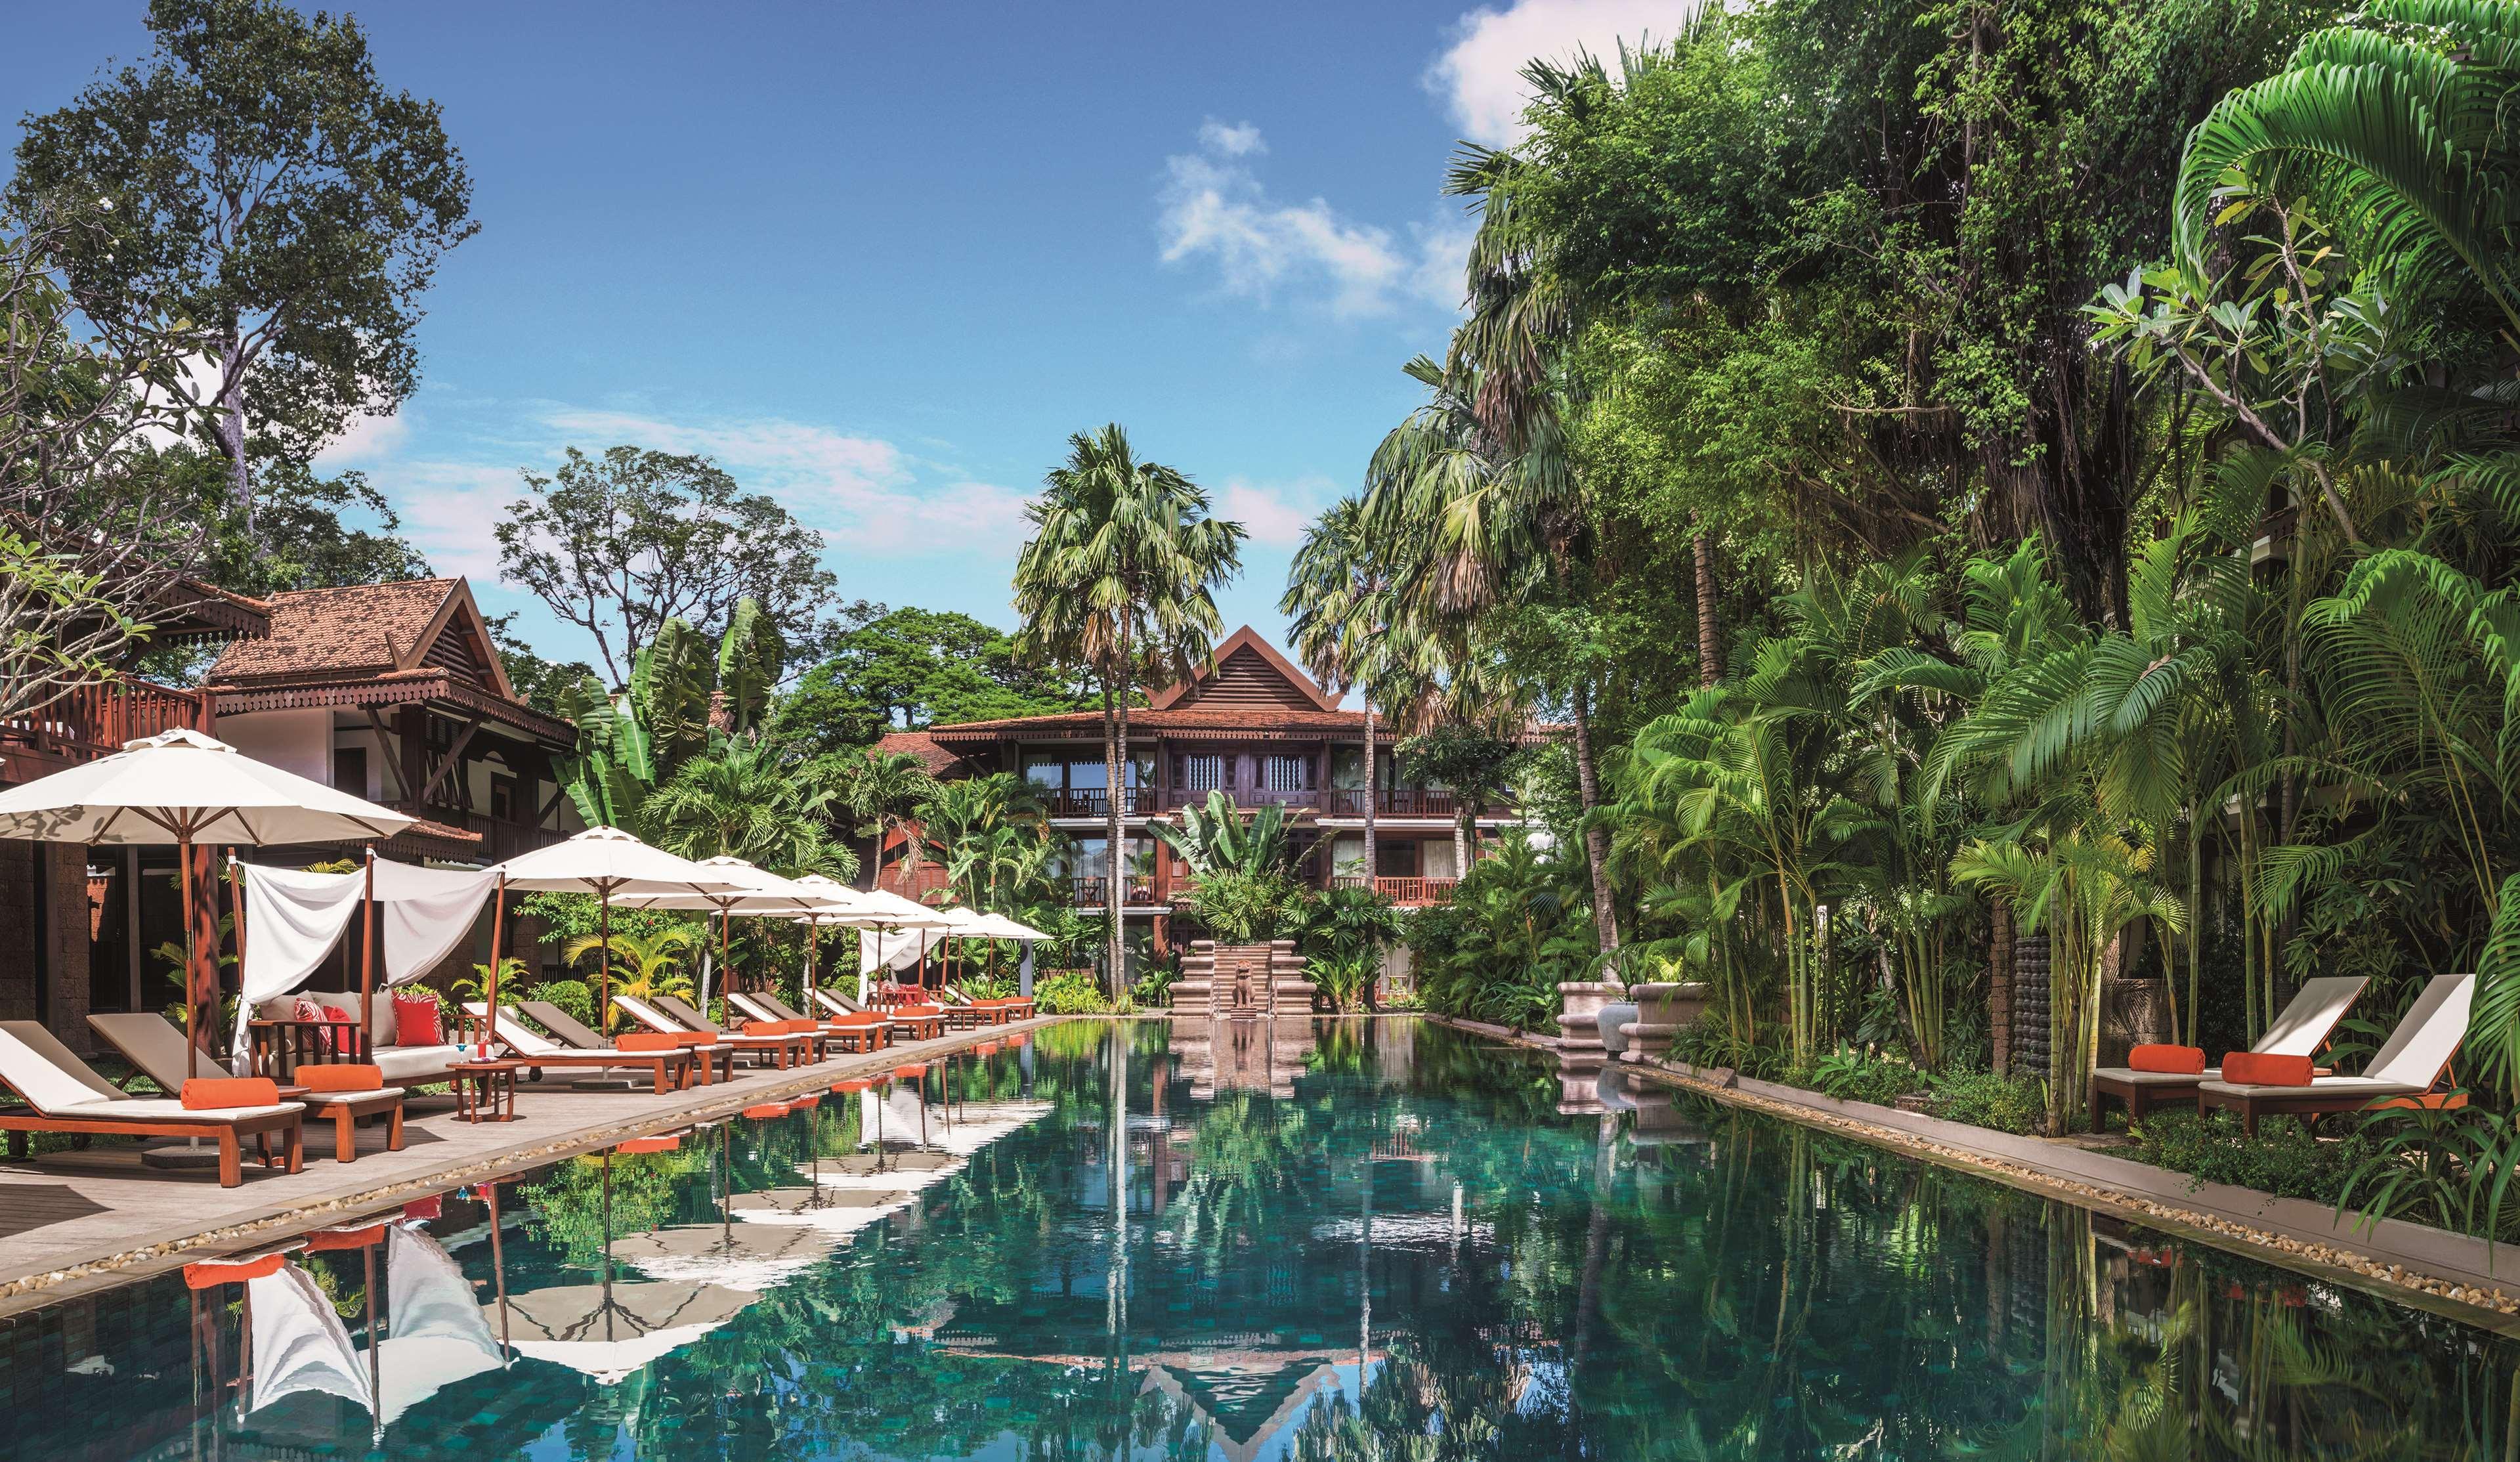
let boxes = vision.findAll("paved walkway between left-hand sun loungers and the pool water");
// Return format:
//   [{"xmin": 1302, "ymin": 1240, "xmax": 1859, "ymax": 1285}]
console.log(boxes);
[{"xmin": 0, "ymin": 1016, "xmax": 1058, "ymax": 1316}]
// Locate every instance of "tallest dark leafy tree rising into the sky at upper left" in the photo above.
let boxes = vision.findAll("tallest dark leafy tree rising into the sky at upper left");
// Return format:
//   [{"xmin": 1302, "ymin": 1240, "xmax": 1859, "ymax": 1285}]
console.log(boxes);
[{"xmin": 10, "ymin": 0, "xmax": 479, "ymax": 514}]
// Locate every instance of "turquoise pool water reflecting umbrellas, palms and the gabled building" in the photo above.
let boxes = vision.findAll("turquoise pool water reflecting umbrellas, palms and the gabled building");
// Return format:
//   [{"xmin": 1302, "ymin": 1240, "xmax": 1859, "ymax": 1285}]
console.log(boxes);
[{"xmin": 0, "ymin": 1021, "xmax": 2520, "ymax": 1462}]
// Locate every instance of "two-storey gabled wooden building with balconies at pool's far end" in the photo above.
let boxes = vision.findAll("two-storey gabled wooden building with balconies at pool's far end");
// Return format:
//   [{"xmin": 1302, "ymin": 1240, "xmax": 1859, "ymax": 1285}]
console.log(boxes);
[{"xmin": 877, "ymin": 628, "xmax": 1520, "ymax": 951}]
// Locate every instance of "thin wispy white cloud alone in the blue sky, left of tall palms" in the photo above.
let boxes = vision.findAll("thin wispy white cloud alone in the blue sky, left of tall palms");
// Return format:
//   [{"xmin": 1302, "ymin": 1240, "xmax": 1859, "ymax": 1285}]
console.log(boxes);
[{"xmin": 1157, "ymin": 121, "xmax": 1469, "ymax": 318}]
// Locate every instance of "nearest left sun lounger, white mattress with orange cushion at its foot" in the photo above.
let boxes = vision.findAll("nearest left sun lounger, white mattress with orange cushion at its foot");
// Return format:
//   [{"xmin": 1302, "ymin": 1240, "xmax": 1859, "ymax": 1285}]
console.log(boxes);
[{"xmin": 0, "ymin": 1021, "xmax": 305, "ymax": 1187}]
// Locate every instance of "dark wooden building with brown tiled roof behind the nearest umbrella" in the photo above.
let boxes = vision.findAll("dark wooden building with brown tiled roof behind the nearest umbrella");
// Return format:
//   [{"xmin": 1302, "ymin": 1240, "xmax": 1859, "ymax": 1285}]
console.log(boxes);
[{"xmin": 0, "ymin": 580, "xmax": 582, "ymax": 1051}]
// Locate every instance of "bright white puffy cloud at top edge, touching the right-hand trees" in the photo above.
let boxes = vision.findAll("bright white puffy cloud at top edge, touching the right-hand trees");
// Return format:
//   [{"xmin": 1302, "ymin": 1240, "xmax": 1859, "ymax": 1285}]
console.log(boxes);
[{"xmin": 1426, "ymin": 0, "xmax": 1701, "ymax": 146}]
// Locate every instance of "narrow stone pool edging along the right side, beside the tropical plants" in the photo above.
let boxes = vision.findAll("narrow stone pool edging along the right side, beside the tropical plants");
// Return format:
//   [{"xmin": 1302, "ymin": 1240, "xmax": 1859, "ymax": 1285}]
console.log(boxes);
[{"xmin": 1429, "ymin": 1016, "xmax": 2520, "ymax": 1336}]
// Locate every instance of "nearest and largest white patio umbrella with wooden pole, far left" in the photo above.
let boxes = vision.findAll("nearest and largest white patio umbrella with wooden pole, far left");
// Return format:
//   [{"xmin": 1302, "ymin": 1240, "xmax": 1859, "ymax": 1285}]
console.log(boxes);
[{"xmin": 0, "ymin": 731, "xmax": 418, "ymax": 1077}]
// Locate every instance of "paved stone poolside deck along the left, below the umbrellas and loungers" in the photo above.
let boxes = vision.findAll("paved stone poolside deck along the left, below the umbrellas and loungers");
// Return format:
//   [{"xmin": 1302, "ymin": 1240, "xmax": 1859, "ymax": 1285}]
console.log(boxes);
[{"xmin": 0, "ymin": 1016, "xmax": 1071, "ymax": 1318}]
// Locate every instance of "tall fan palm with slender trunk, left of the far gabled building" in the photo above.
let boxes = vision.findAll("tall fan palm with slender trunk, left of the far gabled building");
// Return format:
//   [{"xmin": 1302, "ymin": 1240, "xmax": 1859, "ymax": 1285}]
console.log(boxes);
[{"xmin": 1015, "ymin": 423, "xmax": 1243, "ymax": 996}]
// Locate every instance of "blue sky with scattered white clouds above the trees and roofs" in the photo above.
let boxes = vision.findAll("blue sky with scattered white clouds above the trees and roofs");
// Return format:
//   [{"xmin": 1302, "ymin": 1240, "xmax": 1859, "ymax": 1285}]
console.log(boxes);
[{"xmin": 0, "ymin": 0, "xmax": 1691, "ymax": 658}]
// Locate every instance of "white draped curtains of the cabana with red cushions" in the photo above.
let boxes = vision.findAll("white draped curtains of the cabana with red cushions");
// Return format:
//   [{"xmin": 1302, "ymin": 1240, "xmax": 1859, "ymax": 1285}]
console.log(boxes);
[{"xmin": 237, "ymin": 859, "xmax": 499, "ymax": 1056}]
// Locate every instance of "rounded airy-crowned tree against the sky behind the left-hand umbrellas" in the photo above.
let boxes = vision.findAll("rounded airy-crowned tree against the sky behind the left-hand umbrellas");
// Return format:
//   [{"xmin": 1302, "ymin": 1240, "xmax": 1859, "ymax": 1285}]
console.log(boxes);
[{"xmin": 496, "ymin": 446, "xmax": 865, "ymax": 685}]
